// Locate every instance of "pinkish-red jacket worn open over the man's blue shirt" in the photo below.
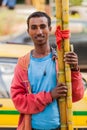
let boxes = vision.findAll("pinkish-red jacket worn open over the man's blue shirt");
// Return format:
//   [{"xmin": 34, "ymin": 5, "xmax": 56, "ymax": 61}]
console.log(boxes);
[{"xmin": 11, "ymin": 53, "xmax": 84, "ymax": 129}]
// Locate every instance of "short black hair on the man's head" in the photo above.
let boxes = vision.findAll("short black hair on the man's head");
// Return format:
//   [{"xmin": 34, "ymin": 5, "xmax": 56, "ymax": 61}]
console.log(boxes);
[{"xmin": 27, "ymin": 11, "xmax": 51, "ymax": 29}]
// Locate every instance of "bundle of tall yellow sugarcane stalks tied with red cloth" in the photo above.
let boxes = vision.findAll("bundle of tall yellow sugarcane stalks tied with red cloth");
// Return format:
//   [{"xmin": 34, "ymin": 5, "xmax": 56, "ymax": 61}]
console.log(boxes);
[{"xmin": 55, "ymin": 0, "xmax": 73, "ymax": 130}]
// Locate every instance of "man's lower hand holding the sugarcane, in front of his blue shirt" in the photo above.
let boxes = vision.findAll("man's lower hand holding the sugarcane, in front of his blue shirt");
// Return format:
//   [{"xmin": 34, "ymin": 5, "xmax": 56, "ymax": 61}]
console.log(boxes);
[{"xmin": 51, "ymin": 83, "xmax": 67, "ymax": 99}]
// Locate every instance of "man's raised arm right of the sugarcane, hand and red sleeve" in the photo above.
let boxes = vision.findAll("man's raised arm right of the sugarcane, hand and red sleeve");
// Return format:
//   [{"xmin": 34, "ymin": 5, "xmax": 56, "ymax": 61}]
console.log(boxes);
[{"xmin": 64, "ymin": 52, "xmax": 84, "ymax": 102}]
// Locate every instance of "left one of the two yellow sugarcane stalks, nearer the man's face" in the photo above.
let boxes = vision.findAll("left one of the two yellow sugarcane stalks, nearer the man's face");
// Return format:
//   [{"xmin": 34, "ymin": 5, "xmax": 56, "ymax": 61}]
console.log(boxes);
[{"xmin": 55, "ymin": 0, "xmax": 67, "ymax": 130}]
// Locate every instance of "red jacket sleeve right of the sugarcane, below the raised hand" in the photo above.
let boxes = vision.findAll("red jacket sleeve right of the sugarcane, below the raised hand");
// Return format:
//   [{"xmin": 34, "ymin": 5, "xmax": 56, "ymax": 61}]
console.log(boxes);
[{"xmin": 71, "ymin": 71, "xmax": 84, "ymax": 102}]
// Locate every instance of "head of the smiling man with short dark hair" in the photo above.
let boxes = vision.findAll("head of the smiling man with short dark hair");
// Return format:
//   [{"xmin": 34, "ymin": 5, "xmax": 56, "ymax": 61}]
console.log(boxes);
[{"xmin": 27, "ymin": 11, "xmax": 51, "ymax": 45}]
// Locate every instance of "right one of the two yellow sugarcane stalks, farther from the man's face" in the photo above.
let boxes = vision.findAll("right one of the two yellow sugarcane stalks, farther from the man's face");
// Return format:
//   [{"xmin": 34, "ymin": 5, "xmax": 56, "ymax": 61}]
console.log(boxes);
[{"xmin": 62, "ymin": 0, "xmax": 73, "ymax": 130}]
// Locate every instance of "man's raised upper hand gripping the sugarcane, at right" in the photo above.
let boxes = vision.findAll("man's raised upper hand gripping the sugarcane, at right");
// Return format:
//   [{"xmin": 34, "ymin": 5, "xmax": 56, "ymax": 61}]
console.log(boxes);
[{"xmin": 64, "ymin": 52, "xmax": 78, "ymax": 70}]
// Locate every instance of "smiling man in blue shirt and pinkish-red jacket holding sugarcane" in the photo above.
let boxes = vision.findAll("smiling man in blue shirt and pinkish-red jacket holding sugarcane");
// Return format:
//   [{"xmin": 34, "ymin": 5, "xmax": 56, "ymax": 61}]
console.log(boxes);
[{"xmin": 11, "ymin": 12, "xmax": 84, "ymax": 130}]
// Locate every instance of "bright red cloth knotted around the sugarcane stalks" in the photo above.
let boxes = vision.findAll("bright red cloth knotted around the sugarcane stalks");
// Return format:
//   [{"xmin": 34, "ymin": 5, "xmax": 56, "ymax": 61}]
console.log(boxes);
[{"xmin": 55, "ymin": 26, "xmax": 70, "ymax": 50}]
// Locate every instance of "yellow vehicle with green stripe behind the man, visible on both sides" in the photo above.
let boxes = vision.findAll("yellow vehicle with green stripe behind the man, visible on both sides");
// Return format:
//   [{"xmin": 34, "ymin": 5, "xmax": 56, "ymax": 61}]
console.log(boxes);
[{"xmin": 0, "ymin": 44, "xmax": 87, "ymax": 130}]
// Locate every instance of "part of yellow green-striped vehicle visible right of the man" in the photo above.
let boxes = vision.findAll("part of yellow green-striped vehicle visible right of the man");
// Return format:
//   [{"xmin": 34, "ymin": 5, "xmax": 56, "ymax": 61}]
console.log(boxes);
[{"xmin": 73, "ymin": 73, "xmax": 87, "ymax": 130}]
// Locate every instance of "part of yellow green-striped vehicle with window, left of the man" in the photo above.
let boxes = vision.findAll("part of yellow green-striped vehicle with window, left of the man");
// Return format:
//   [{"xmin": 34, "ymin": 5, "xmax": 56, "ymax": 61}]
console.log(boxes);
[{"xmin": 0, "ymin": 44, "xmax": 33, "ymax": 130}]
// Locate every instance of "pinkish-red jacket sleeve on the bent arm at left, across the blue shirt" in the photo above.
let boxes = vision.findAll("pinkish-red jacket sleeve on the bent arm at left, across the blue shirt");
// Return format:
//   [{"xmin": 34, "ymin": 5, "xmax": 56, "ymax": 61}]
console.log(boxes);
[{"xmin": 11, "ymin": 65, "xmax": 52, "ymax": 114}]
